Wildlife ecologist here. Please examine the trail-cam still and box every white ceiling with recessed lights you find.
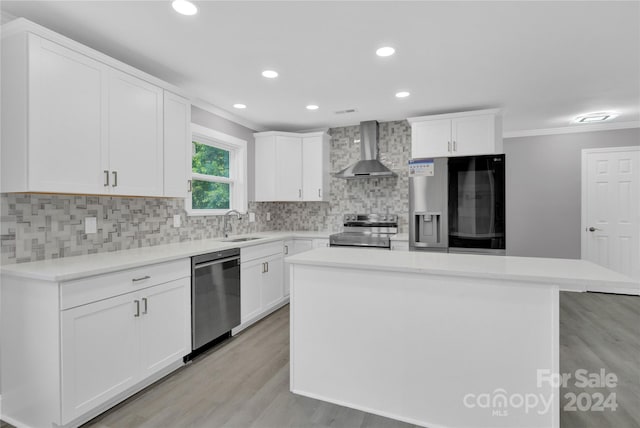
[0,0,640,132]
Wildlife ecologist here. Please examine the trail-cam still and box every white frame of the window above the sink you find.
[185,123,248,216]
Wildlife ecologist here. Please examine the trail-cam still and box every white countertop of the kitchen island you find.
[286,248,640,294]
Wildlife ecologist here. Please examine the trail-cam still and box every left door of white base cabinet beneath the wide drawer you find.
[61,293,141,424]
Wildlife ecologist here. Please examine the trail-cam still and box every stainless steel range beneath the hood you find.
[329,214,398,249]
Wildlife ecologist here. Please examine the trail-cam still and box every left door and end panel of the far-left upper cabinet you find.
[2,33,108,193]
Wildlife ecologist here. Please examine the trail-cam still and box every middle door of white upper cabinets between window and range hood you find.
[276,136,302,201]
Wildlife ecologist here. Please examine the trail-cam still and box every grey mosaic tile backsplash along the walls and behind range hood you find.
[0,121,411,264]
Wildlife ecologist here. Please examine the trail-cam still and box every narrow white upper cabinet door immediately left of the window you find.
[163,91,191,198]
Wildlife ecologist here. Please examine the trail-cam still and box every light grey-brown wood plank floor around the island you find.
[0,293,640,428]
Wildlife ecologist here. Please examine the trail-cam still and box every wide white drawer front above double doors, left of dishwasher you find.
[60,259,191,310]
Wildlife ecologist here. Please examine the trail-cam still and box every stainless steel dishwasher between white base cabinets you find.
[191,248,240,351]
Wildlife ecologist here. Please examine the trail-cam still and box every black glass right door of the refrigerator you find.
[448,155,505,252]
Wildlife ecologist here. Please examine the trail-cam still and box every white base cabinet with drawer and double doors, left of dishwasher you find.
[0,259,191,427]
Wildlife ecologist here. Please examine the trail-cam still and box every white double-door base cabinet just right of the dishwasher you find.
[240,241,287,332]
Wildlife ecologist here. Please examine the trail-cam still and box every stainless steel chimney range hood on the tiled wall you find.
[333,120,397,178]
